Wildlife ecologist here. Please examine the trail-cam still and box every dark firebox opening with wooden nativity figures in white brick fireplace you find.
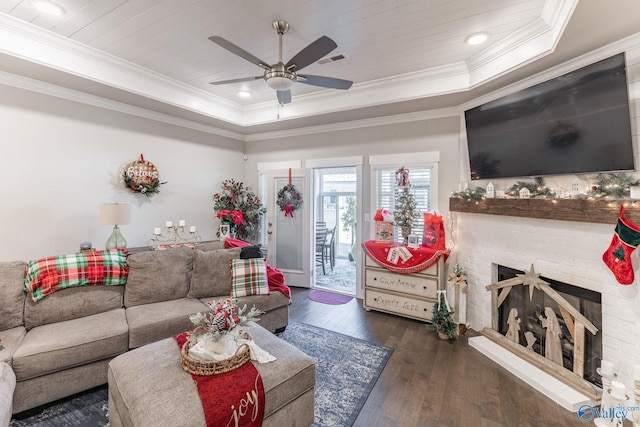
[494,266,602,387]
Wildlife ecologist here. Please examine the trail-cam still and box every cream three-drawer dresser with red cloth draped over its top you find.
[362,242,449,321]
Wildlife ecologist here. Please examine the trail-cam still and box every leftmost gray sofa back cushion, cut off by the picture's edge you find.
[0,261,27,331]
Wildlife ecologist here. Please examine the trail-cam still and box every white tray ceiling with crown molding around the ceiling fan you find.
[0,0,628,135]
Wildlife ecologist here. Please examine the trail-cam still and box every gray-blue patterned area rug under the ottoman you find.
[10,322,393,427]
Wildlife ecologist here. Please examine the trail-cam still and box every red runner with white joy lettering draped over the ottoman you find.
[173,332,264,427]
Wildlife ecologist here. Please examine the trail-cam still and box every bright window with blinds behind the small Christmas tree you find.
[373,167,432,241]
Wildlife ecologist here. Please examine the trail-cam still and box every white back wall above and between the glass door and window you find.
[245,116,460,244]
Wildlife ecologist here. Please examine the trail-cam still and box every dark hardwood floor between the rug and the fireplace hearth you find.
[289,288,600,427]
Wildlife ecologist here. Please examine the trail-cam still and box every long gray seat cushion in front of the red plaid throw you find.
[13,308,128,381]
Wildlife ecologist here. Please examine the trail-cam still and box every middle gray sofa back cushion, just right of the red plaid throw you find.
[124,248,193,307]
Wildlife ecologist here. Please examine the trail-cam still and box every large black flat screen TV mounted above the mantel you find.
[465,53,634,179]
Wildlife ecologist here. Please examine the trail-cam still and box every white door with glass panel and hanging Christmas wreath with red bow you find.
[266,169,312,288]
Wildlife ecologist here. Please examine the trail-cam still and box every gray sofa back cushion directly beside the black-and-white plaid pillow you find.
[187,248,241,298]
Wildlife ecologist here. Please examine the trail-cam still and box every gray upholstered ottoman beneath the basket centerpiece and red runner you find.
[108,324,316,427]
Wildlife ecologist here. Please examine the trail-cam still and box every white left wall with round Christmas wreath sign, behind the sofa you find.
[0,85,244,261]
